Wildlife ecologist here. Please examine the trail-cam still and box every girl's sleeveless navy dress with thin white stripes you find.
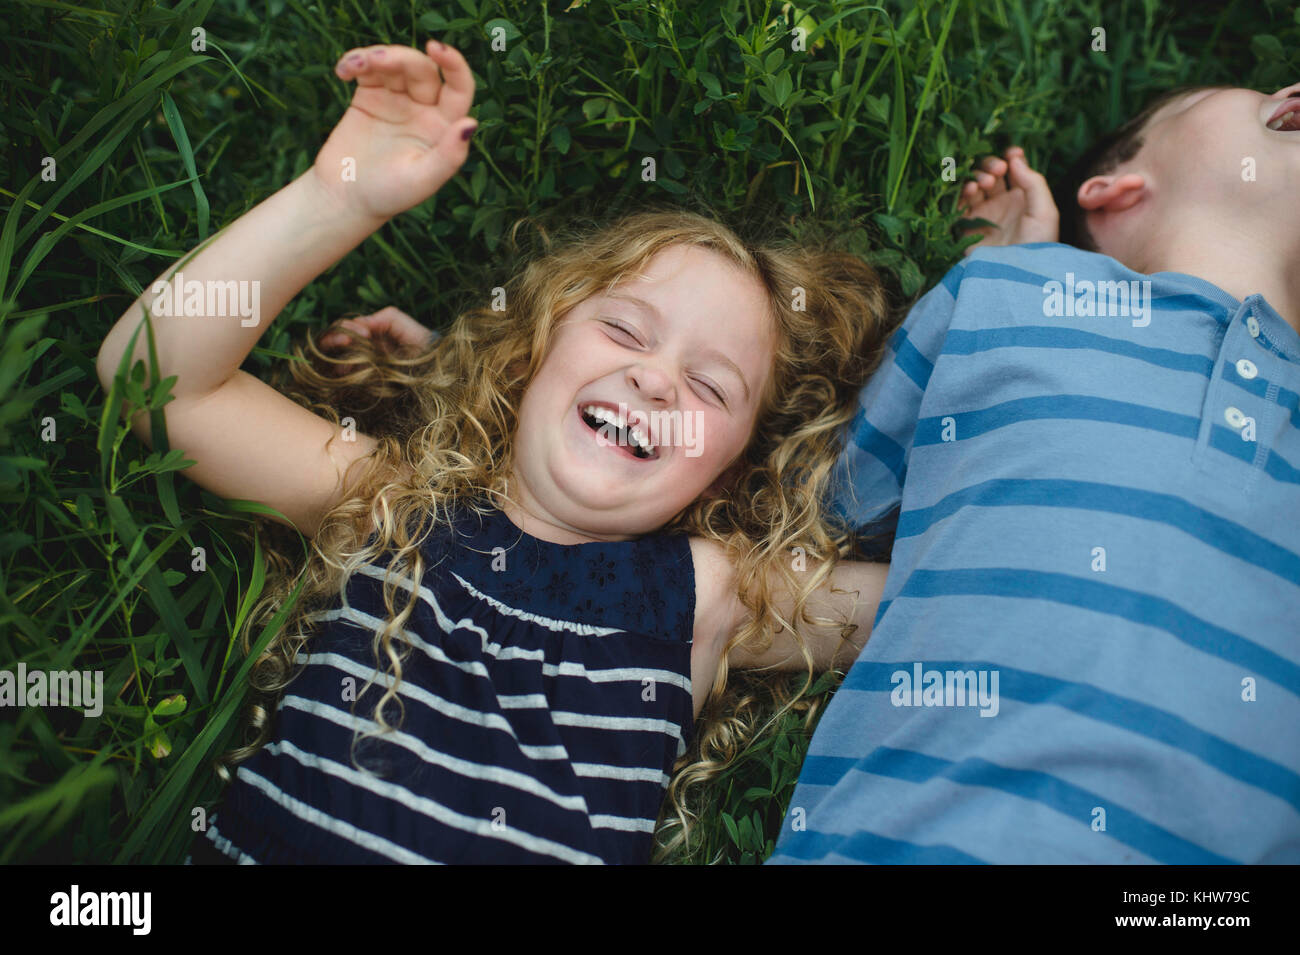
[192,509,696,864]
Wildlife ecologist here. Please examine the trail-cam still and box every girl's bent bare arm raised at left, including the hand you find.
[96,40,476,537]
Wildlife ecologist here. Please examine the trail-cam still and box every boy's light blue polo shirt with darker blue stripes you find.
[770,243,1300,864]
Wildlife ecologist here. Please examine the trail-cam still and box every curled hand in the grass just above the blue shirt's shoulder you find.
[958,146,1061,255]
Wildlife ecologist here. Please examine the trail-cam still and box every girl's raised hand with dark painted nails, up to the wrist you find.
[312,40,478,220]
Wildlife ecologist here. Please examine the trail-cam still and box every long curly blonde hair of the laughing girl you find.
[217,209,889,859]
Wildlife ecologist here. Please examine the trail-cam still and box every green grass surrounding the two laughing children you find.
[0,0,1300,863]
